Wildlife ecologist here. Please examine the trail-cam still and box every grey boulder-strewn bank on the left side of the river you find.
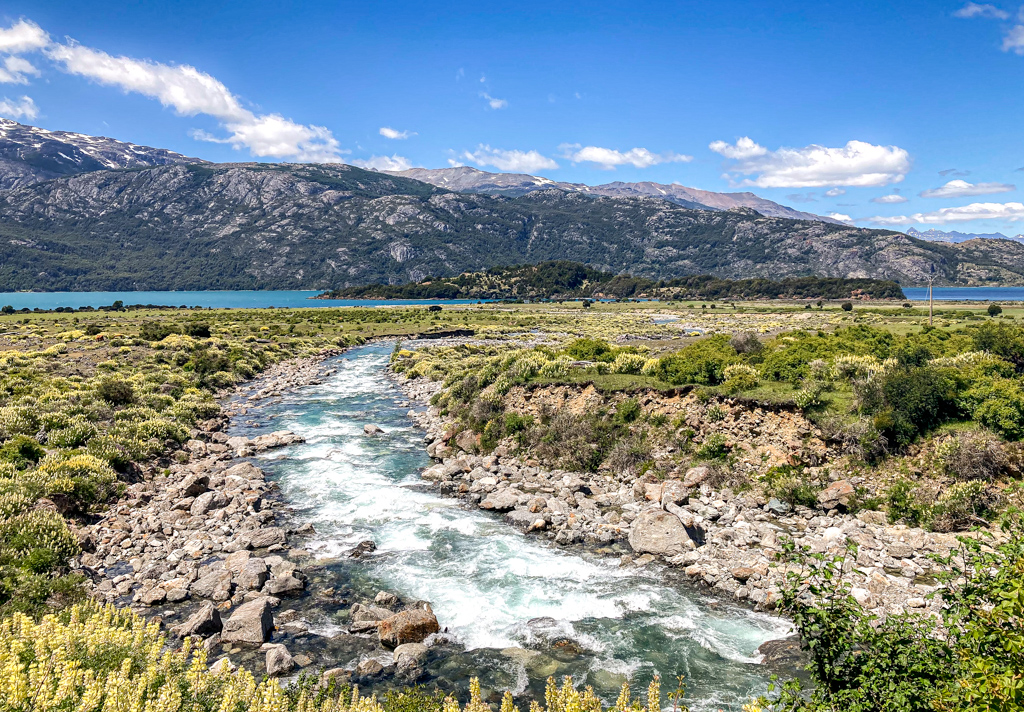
[78,349,443,683]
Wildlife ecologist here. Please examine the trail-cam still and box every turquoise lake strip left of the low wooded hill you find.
[0,290,487,309]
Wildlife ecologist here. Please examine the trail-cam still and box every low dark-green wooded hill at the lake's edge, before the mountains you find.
[316,260,905,300]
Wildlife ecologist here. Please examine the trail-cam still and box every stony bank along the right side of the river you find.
[396,376,974,615]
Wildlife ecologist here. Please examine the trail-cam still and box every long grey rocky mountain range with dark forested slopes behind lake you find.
[0,122,1024,291]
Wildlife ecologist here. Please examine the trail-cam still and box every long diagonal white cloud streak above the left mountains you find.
[46,42,343,162]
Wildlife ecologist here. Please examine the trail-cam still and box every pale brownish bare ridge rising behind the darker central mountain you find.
[382,166,842,224]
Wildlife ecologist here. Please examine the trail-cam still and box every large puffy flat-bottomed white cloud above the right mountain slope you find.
[710,138,910,187]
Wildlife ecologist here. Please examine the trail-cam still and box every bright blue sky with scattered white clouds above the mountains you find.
[0,0,1024,235]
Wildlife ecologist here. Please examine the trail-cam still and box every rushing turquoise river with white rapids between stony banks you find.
[234,344,790,710]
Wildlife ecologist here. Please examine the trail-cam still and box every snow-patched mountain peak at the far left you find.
[0,119,207,191]
